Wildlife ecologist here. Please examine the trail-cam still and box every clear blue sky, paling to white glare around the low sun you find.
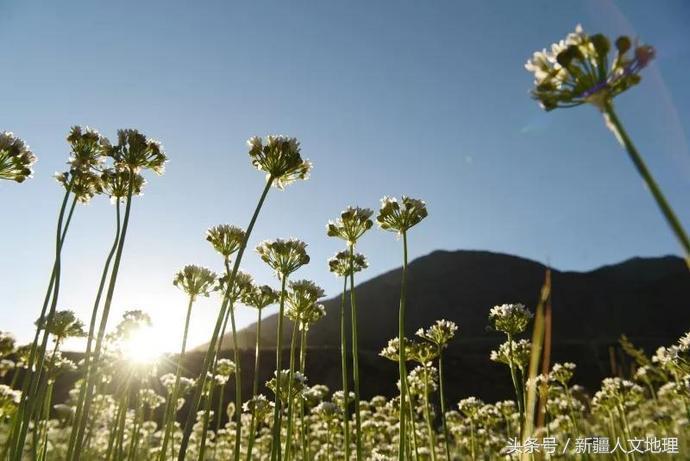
[0,0,690,347]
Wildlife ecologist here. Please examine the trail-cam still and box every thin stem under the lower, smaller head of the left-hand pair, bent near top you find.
[67,198,120,459]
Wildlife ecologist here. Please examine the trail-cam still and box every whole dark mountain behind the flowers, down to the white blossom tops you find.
[197,251,690,398]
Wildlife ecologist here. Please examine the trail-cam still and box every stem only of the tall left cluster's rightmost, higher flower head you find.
[69,169,134,461]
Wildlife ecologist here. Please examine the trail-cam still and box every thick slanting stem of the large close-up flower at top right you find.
[602,101,690,269]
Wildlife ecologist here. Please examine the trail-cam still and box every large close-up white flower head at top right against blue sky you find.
[525,25,654,110]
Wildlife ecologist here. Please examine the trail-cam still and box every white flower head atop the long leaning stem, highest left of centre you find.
[247,136,311,189]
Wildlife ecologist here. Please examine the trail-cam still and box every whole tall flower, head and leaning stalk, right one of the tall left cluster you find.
[67,129,167,461]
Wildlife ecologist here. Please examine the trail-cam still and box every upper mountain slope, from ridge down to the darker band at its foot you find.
[201,251,690,352]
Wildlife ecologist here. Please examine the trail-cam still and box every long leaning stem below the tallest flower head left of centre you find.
[178,177,274,461]
